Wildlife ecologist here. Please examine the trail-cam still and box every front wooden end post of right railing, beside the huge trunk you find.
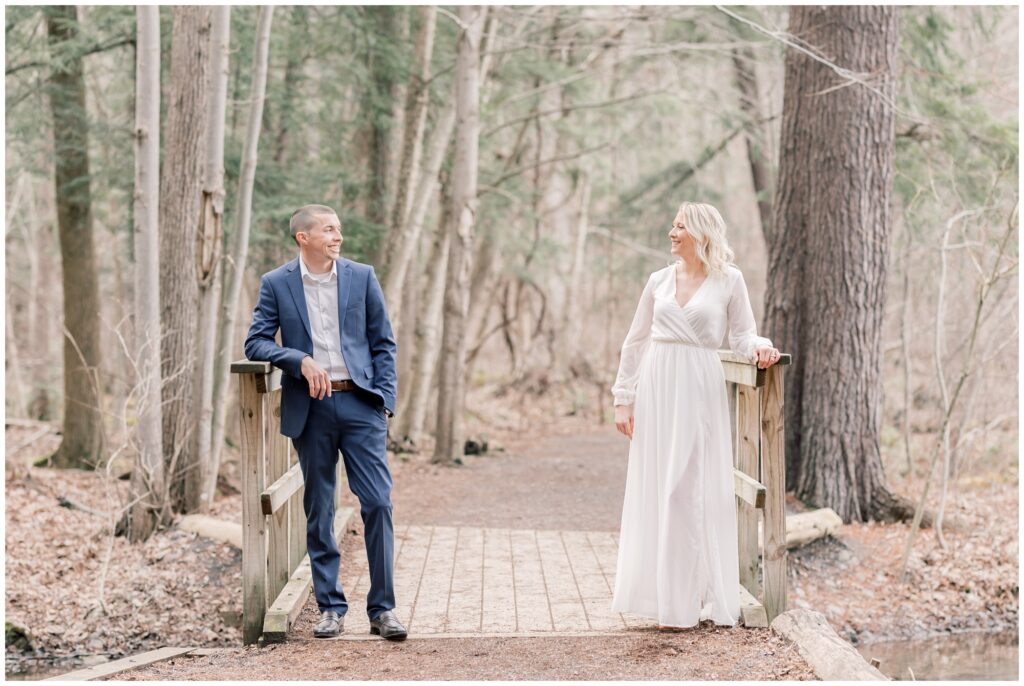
[761,365,788,621]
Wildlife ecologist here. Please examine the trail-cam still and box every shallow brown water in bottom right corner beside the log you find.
[857,631,1020,681]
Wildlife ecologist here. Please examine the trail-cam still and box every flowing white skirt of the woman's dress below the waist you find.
[612,340,739,627]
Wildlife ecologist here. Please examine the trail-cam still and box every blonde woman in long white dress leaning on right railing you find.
[611,203,779,628]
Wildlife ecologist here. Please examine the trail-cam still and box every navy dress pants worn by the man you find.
[292,391,394,619]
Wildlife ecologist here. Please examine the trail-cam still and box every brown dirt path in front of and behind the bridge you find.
[112,428,813,680]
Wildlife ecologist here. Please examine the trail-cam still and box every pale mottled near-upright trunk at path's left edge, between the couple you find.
[433,5,487,464]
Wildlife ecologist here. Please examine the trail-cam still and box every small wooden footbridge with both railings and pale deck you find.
[231,351,791,644]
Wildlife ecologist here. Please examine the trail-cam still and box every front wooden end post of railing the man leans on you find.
[239,373,266,645]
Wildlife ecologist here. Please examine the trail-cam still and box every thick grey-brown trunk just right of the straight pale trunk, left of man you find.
[160,6,211,511]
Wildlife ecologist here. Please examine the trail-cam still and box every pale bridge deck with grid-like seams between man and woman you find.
[342,525,653,639]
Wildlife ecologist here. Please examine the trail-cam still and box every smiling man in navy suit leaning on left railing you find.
[246,205,407,641]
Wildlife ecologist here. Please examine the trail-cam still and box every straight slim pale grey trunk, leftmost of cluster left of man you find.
[122,5,169,542]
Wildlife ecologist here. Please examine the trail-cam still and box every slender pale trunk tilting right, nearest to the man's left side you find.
[203,5,273,503]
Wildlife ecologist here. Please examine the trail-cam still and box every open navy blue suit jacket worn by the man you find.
[246,258,397,438]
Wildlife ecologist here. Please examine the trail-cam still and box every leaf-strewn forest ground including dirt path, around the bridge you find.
[5,389,1018,680]
